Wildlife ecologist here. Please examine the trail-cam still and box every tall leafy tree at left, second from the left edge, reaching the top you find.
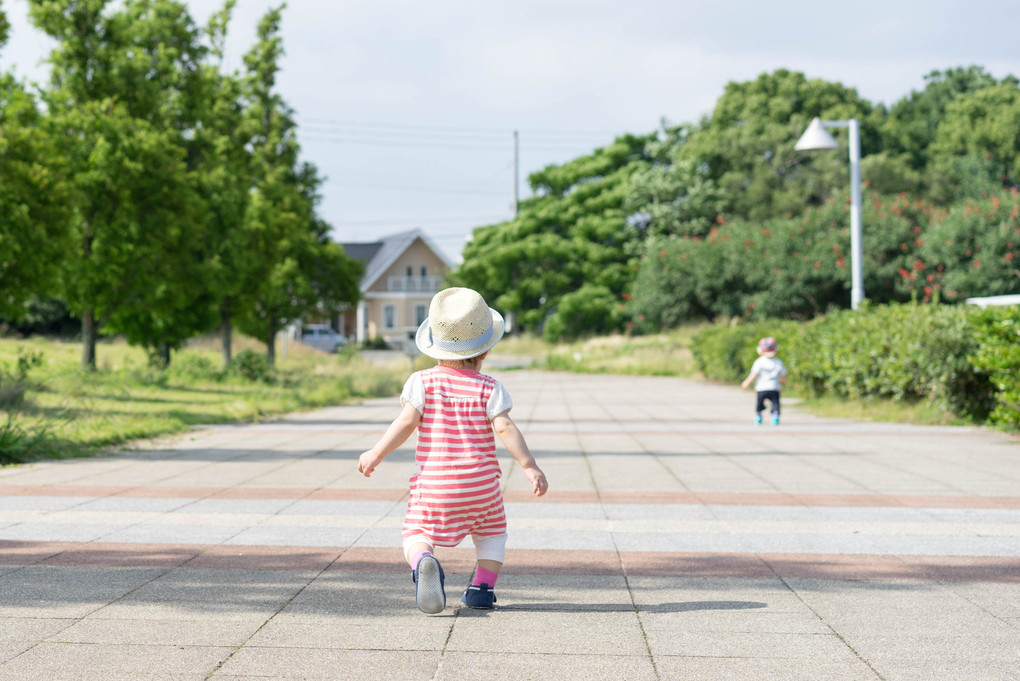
[30,0,211,368]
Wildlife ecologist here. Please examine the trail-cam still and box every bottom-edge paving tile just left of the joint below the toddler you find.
[213,646,442,681]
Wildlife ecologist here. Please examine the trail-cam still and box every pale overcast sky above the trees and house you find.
[0,0,1020,260]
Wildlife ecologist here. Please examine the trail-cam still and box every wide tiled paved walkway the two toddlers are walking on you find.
[0,370,1020,681]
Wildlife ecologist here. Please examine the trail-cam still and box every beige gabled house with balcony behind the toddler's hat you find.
[339,229,454,345]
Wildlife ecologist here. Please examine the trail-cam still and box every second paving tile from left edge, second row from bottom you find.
[52,618,258,647]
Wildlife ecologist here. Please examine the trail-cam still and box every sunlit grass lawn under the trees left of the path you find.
[0,337,422,463]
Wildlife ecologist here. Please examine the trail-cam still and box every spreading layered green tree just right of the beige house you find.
[451,135,652,337]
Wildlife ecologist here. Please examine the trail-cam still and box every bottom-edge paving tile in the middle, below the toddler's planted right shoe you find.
[436,650,656,681]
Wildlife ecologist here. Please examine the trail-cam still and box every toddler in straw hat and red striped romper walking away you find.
[358,289,549,615]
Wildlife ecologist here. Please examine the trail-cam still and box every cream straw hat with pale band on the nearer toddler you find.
[414,289,504,360]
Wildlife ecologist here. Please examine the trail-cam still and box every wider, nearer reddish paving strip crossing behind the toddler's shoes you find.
[0,541,1020,584]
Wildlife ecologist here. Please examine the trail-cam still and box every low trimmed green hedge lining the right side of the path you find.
[693,304,1020,428]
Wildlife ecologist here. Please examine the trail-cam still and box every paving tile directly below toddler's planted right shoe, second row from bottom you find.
[446,609,648,656]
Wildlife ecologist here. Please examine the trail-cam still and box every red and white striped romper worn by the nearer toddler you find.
[401,366,507,546]
